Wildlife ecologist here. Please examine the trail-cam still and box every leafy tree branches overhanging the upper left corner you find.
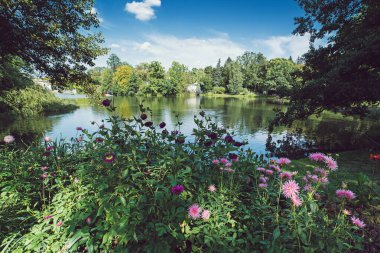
[0,0,106,86]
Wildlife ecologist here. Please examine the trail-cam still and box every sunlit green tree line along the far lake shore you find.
[88,52,302,96]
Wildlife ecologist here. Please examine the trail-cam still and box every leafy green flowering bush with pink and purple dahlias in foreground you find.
[0,104,363,252]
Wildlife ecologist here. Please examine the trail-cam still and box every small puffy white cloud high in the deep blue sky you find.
[125,0,161,21]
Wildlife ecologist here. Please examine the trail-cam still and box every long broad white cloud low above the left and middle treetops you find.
[96,34,246,69]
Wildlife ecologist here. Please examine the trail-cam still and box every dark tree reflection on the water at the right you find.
[267,115,380,157]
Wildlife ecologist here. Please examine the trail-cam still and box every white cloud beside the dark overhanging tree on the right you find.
[253,34,310,60]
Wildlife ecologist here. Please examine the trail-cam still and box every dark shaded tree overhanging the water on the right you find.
[275,0,380,124]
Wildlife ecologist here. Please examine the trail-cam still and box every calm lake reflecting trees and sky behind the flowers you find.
[0,94,380,154]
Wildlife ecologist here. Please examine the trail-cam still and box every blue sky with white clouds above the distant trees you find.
[91,0,309,69]
